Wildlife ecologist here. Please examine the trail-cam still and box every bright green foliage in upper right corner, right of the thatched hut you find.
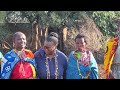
[87,11,120,36]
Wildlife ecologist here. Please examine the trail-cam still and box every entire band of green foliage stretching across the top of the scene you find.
[0,11,120,36]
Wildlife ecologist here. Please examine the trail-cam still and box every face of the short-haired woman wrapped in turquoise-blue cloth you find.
[75,38,86,51]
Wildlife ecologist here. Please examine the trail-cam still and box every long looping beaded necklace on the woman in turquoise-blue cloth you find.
[74,51,90,79]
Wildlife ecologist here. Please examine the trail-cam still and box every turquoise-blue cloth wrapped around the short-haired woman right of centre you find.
[66,51,98,79]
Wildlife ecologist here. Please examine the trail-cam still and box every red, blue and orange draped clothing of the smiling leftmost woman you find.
[1,49,36,79]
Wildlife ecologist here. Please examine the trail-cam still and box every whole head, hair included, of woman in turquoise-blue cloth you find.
[75,34,87,51]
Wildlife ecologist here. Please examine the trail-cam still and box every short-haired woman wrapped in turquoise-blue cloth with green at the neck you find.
[66,34,98,79]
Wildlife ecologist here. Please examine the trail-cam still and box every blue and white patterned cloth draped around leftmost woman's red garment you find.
[1,50,36,79]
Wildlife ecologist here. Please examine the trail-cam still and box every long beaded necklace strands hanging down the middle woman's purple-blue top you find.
[46,54,59,79]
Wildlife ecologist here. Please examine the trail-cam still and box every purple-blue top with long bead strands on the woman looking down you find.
[34,48,67,79]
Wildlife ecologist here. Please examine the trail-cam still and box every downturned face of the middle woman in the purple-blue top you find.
[43,41,56,55]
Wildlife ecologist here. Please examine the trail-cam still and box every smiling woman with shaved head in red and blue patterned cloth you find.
[1,32,36,79]
